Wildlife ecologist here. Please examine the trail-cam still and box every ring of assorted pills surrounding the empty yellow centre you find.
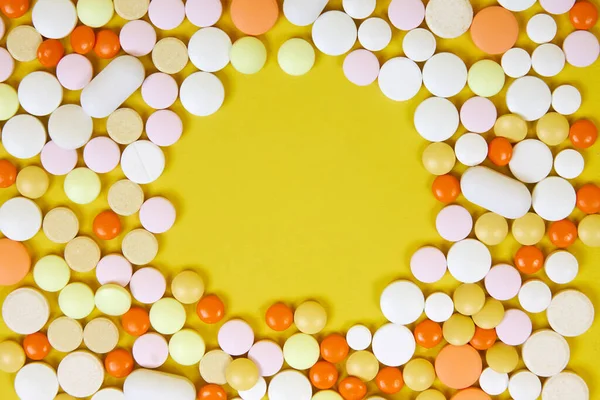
[0,0,600,400]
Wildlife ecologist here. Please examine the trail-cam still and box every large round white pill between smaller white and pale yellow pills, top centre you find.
[312,11,358,56]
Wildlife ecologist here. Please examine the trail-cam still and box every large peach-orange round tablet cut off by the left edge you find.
[0,238,31,286]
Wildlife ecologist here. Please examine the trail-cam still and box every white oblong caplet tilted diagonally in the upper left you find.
[81,56,144,118]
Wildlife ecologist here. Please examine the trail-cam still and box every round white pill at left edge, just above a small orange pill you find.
[2,114,46,159]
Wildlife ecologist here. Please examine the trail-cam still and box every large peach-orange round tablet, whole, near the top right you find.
[471,6,519,54]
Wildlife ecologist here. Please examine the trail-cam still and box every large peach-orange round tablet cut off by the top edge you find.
[230,0,279,36]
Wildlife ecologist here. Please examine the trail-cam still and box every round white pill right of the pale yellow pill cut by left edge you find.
[18,71,63,117]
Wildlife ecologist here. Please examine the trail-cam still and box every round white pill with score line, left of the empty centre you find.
[121,140,165,185]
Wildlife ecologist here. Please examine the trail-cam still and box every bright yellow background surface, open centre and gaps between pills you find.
[0,0,600,400]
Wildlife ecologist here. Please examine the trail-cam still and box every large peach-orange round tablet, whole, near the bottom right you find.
[435,344,482,389]
